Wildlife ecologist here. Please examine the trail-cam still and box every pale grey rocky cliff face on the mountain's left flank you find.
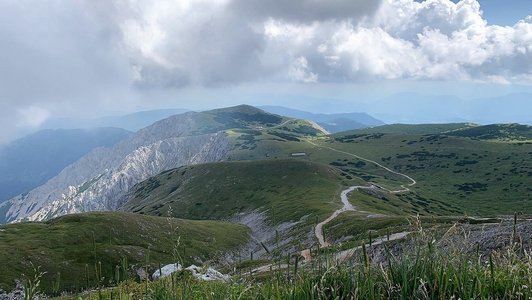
[6,113,229,222]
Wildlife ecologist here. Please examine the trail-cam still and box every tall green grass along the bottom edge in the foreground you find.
[72,226,532,299]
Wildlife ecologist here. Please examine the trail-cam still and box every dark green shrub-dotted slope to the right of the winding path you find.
[321,129,532,215]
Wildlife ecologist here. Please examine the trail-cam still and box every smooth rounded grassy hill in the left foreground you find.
[0,213,249,292]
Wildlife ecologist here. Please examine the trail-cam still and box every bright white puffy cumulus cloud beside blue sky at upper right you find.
[265,0,532,82]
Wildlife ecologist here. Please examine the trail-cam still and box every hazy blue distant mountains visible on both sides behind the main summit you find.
[0,106,383,220]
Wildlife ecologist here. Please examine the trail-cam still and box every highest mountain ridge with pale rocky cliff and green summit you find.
[6,105,321,222]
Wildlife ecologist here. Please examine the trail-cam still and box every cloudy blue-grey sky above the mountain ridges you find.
[0,0,532,143]
